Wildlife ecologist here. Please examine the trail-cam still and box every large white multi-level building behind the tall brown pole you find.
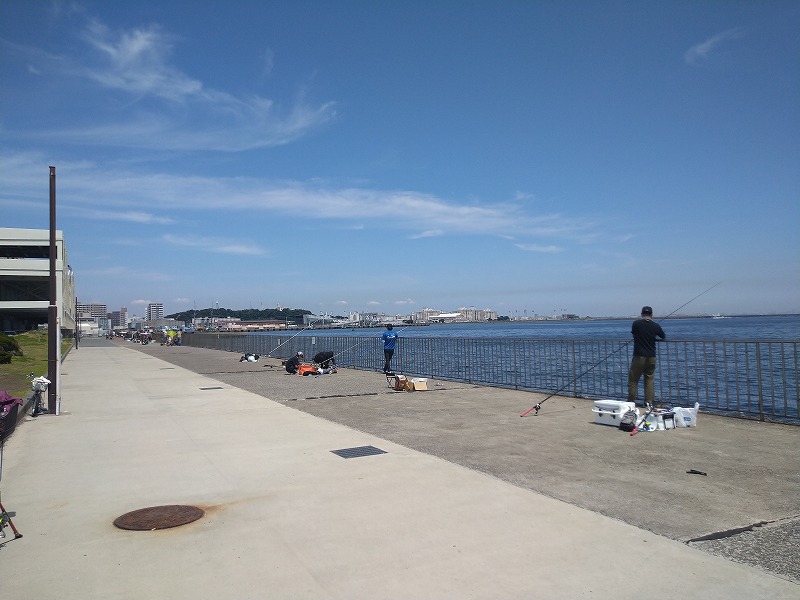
[0,227,76,334]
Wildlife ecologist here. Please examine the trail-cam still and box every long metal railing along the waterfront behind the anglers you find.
[183,333,800,423]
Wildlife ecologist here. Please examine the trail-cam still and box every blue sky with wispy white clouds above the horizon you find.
[0,0,800,316]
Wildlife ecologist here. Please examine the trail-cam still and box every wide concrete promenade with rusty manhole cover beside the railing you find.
[0,339,800,600]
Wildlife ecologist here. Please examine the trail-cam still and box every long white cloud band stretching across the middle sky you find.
[0,151,607,248]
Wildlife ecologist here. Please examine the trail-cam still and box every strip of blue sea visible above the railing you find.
[282,315,800,341]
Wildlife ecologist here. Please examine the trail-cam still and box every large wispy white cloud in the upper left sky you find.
[12,20,336,152]
